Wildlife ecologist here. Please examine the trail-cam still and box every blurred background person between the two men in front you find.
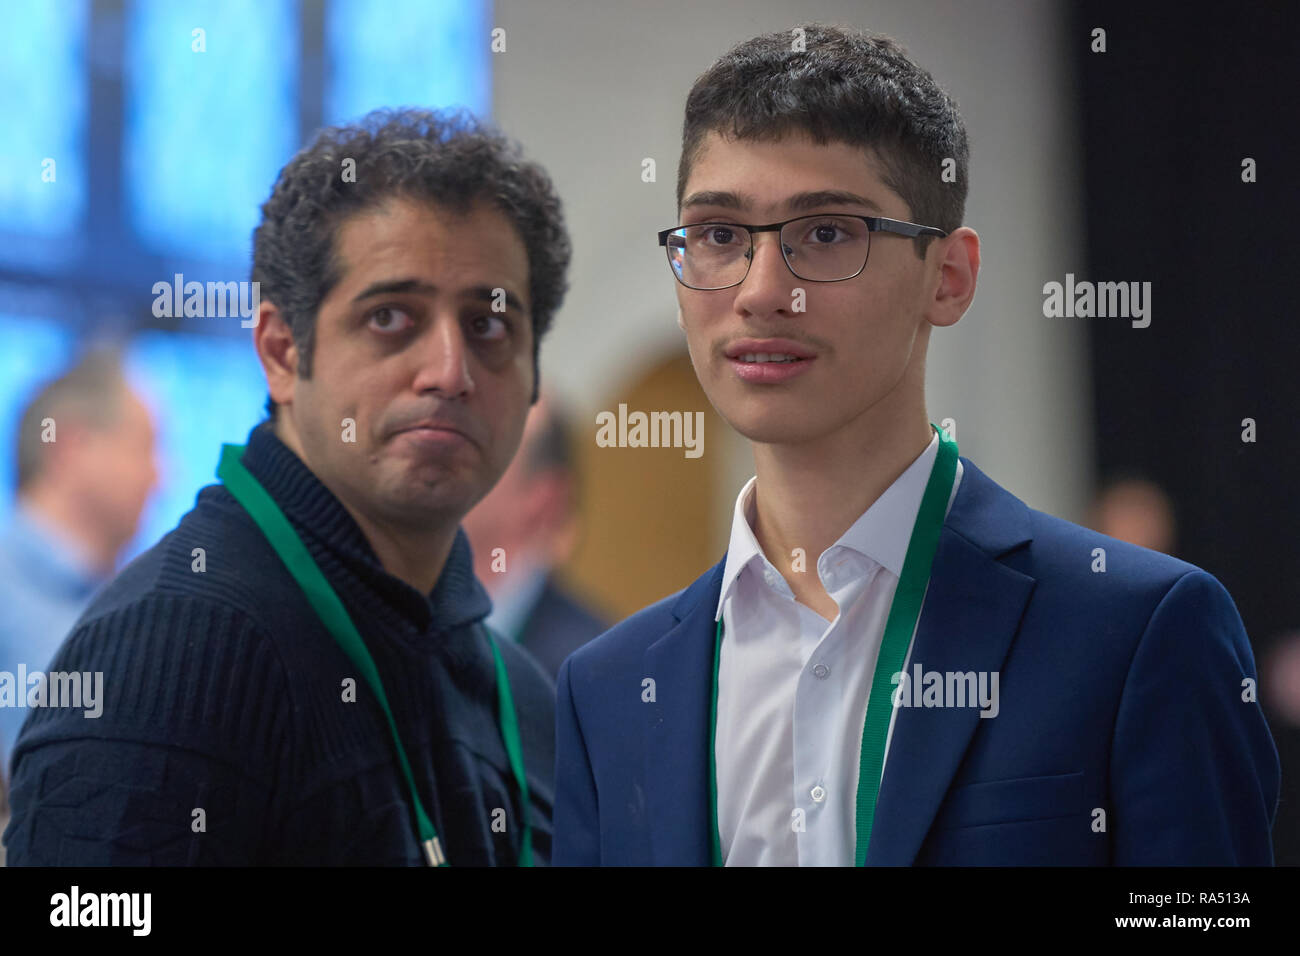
[464,394,610,678]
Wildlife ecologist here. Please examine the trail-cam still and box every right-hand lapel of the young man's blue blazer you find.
[867,458,1035,866]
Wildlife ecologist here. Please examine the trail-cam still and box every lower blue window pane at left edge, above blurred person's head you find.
[0,313,73,516]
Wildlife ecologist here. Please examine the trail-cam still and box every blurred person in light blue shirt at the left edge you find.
[0,349,157,775]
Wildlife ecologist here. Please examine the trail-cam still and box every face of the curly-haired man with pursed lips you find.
[294,202,533,533]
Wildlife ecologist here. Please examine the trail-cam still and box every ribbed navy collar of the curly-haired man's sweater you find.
[242,420,491,635]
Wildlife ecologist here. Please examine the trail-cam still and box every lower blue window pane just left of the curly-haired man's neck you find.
[122,332,267,561]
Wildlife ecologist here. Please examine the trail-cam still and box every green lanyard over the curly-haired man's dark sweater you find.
[217,445,533,866]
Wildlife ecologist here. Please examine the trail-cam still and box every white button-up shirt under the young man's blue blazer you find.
[715,434,962,866]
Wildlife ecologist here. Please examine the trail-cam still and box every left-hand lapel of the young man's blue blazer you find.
[644,557,727,866]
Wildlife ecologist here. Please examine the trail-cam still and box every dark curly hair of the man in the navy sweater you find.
[252,109,572,418]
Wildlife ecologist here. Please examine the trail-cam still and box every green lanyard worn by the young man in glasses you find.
[709,424,957,866]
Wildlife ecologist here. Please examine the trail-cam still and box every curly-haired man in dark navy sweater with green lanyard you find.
[5,111,569,865]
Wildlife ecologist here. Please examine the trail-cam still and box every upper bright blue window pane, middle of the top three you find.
[122,0,299,261]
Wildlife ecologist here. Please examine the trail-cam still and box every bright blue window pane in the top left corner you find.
[0,0,90,238]
